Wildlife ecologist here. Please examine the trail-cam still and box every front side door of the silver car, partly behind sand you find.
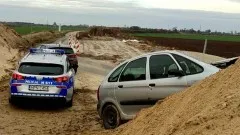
[149,54,187,104]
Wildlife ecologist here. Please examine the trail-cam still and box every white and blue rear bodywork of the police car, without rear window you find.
[10,48,75,101]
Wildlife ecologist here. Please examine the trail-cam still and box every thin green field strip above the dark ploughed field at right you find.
[132,33,240,42]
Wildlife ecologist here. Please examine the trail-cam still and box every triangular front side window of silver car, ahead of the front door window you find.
[172,54,204,75]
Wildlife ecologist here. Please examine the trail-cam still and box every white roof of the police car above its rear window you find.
[21,53,67,65]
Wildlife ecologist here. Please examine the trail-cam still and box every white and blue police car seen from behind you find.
[9,48,75,107]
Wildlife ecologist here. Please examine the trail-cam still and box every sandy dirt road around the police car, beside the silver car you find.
[0,33,119,135]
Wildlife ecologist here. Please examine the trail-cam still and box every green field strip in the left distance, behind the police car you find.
[12,26,87,35]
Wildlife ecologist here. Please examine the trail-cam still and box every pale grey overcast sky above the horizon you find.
[0,0,240,32]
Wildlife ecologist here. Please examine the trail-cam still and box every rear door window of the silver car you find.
[119,57,147,82]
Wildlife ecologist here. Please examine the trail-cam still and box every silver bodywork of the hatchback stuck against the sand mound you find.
[97,51,219,120]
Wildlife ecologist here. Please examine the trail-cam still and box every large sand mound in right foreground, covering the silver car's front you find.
[111,61,240,135]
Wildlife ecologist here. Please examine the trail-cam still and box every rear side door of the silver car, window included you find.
[115,57,148,115]
